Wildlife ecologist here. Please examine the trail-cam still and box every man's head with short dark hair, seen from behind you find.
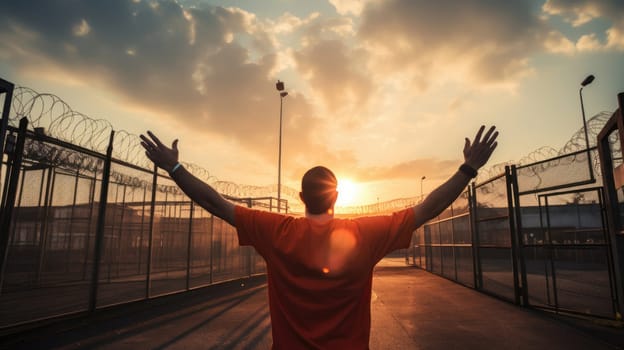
[299,166,338,215]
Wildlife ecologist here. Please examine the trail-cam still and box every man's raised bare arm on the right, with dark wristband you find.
[413,126,498,227]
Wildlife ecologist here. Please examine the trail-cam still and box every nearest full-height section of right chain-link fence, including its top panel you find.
[515,149,618,318]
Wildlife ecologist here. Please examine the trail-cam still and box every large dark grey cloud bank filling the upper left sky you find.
[0,0,322,164]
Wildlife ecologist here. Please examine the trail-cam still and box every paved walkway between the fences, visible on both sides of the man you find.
[0,261,624,350]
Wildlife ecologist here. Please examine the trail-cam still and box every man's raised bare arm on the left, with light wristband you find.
[141,131,235,225]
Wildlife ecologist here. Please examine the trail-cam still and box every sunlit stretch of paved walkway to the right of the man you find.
[370,265,624,350]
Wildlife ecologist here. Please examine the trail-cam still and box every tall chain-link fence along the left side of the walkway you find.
[0,119,276,328]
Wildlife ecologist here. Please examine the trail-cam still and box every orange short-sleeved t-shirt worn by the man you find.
[235,206,415,350]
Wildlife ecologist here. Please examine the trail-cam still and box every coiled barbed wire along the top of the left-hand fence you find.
[9,86,298,202]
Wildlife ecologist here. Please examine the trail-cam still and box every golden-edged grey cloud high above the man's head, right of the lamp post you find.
[268,13,375,132]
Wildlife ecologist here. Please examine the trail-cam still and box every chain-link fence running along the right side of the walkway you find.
[408,149,619,318]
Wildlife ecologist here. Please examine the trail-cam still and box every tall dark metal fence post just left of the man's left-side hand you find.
[89,130,115,312]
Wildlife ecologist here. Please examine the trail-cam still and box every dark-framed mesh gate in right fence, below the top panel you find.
[523,187,616,318]
